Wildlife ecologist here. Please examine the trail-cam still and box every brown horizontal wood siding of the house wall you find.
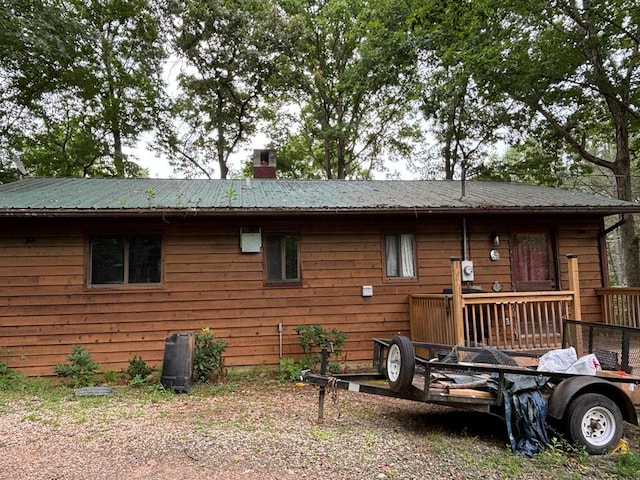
[0,216,602,375]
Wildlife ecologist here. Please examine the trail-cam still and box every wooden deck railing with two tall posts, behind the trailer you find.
[409,256,584,351]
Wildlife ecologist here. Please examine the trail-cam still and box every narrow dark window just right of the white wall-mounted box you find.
[265,235,300,283]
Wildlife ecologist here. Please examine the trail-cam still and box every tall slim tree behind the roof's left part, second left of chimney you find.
[62,0,166,177]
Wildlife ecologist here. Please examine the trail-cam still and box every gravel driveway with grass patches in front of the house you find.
[0,379,640,480]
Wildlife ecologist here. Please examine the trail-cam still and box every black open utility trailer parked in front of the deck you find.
[302,336,640,454]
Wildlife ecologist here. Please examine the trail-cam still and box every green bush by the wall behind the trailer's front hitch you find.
[295,325,347,373]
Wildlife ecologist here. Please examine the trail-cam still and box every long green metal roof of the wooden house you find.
[0,178,640,216]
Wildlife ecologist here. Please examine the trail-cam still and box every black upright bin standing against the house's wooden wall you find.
[160,333,195,393]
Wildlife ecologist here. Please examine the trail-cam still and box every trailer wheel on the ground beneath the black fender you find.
[566,393,623,455]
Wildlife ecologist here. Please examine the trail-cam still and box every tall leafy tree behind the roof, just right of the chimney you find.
[272,0,419,179]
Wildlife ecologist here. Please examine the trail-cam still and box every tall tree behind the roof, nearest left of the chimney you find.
[161,0,294,178]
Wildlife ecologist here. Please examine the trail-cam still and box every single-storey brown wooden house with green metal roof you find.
[0,174,640,375]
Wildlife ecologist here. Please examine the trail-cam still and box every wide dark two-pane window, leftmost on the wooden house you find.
[89,235,162,285]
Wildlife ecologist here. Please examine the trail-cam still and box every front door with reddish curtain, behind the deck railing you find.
[510,230,558,292]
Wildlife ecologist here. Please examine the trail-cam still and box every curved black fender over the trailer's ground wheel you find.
[547,376,638,425]
